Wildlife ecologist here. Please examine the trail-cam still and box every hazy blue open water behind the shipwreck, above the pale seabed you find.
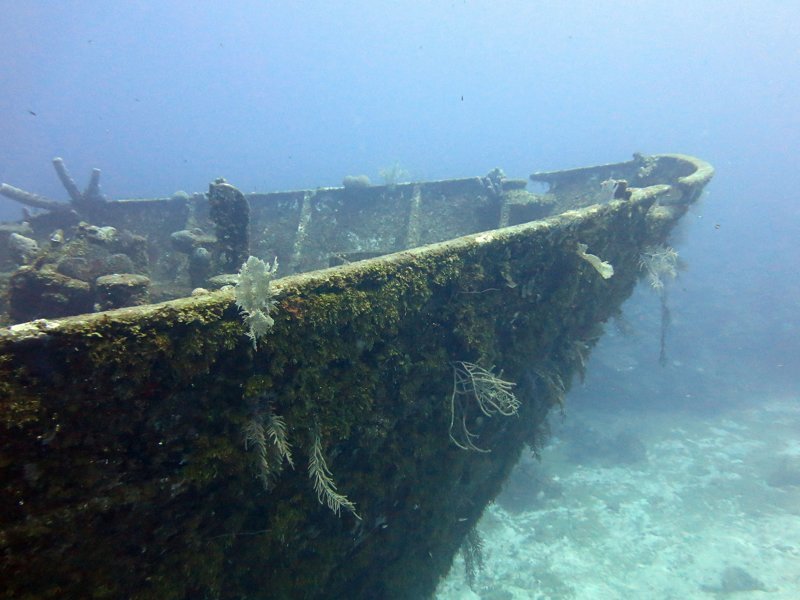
[0,0,800,596]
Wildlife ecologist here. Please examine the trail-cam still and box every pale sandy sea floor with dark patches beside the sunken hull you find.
[436,395,800,600]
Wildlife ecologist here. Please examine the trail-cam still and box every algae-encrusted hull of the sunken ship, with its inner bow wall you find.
[0,155,713,598]
